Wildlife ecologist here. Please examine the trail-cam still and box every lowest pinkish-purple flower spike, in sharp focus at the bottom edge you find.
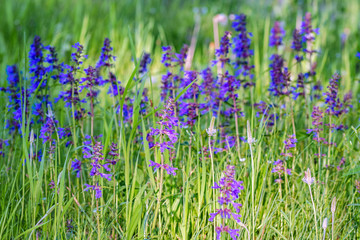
[209,165,244,239]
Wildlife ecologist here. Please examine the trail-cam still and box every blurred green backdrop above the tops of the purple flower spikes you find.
[0,0,360,88]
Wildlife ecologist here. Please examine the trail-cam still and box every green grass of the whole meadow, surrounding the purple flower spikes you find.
[0,0,360,239]
